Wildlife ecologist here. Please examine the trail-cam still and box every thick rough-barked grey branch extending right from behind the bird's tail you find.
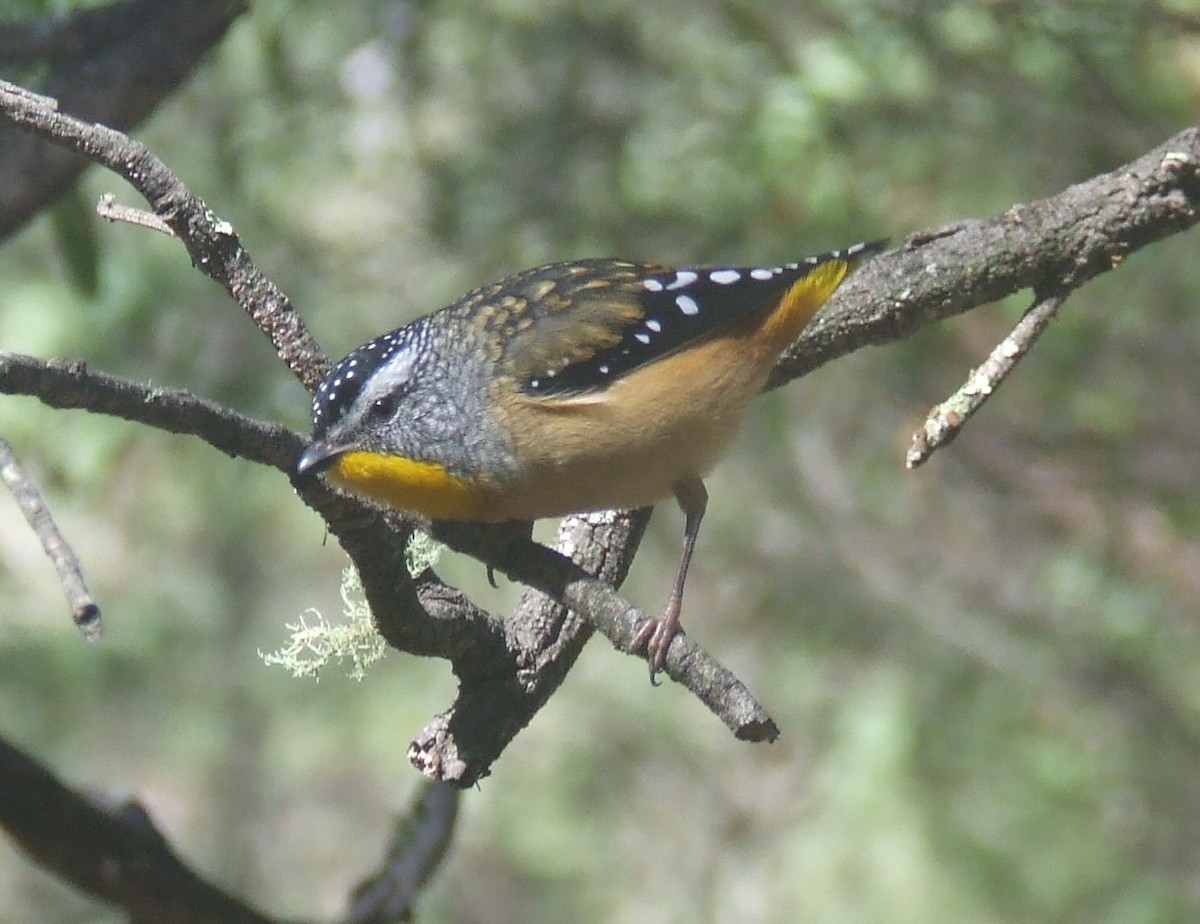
[769,135,1200,388]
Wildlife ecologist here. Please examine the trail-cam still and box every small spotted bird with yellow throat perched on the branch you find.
[295,241,886,679]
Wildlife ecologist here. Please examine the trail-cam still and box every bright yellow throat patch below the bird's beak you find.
[328,452,482,520]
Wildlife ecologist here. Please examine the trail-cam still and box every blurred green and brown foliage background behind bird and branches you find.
[0,0,1200,924]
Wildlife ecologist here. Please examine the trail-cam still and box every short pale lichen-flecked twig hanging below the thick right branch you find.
[905,293,1067,468]
